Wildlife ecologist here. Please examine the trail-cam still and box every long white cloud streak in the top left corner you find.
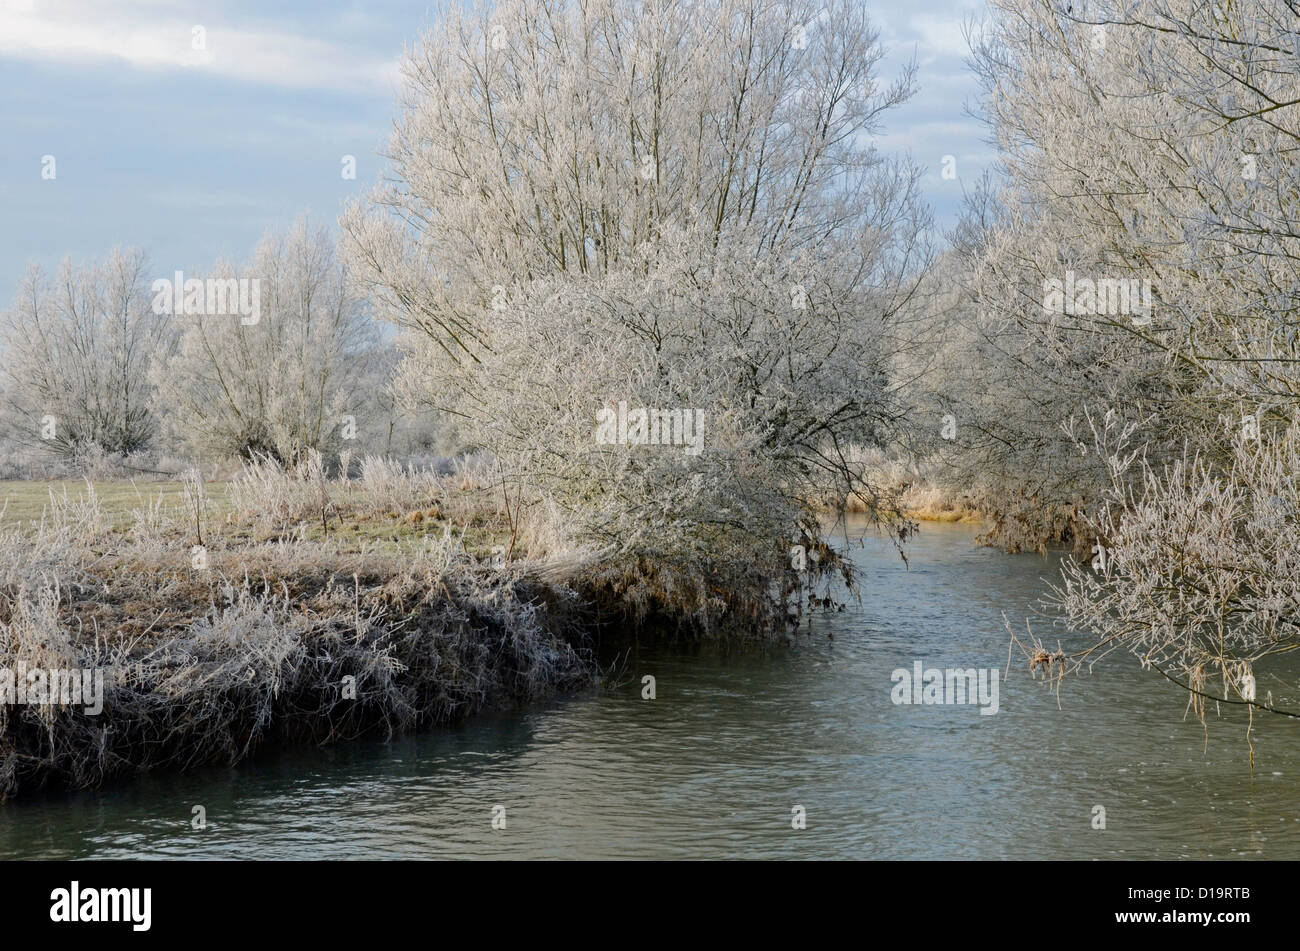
[0,0,398,91]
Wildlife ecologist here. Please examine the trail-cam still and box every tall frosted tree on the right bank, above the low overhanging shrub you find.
[948,0,1300,547]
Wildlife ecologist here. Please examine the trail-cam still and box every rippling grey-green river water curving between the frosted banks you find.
[0,524,1300,859]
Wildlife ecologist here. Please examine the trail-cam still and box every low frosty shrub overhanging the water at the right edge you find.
[1017,417,1300,748]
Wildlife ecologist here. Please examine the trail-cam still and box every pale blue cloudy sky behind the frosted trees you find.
[0,0,991,309]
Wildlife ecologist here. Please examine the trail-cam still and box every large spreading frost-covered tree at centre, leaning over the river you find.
[345,0,927,631]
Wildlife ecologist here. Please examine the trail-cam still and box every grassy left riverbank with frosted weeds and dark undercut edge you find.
[0,461,598,798]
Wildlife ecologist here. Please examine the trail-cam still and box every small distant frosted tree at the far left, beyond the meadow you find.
[0,249,161,456]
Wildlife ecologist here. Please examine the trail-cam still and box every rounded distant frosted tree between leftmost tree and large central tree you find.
[152,220,378,464]
